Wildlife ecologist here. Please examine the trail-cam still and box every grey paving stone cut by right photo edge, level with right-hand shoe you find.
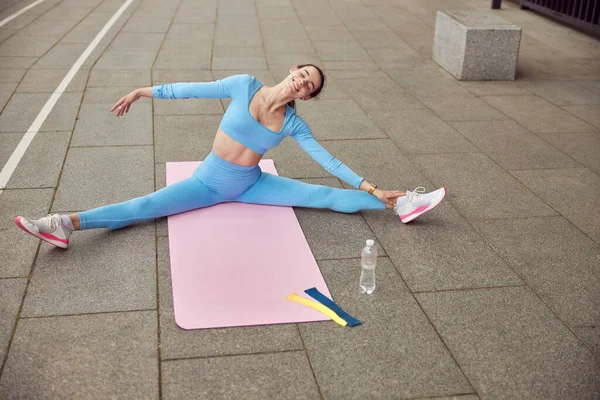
[511,168,600,244]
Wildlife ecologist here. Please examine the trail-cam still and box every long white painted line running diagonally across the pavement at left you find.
[0,0,133,194]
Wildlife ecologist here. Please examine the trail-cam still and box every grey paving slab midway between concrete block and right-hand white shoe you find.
[369,110,479,154]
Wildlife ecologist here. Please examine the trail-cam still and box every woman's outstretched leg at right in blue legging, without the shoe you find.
[236,172,385,213]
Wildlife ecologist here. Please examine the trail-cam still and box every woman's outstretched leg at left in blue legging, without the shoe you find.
[77,176,223,229]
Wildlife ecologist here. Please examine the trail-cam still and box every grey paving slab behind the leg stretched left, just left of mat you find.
[53,146,154,211]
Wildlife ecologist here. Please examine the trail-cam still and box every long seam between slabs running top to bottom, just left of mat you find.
[145,0,182,400]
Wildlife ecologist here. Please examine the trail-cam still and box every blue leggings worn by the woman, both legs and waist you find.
[78,152,385,229]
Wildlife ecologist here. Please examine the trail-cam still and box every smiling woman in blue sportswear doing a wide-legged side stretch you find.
[15,64,445,249]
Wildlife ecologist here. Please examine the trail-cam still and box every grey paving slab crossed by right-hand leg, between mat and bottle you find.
[294,178,385,260]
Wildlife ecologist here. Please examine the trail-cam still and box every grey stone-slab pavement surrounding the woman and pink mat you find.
[0,0,600,400]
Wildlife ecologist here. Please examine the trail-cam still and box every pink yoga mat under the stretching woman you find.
[167,160,331,329]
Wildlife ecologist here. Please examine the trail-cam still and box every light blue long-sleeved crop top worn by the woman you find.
[152,75,363,188]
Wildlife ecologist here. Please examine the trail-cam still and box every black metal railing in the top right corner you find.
[502,0,600,37]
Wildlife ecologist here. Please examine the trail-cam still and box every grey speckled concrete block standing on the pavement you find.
[433,11,521,80]
